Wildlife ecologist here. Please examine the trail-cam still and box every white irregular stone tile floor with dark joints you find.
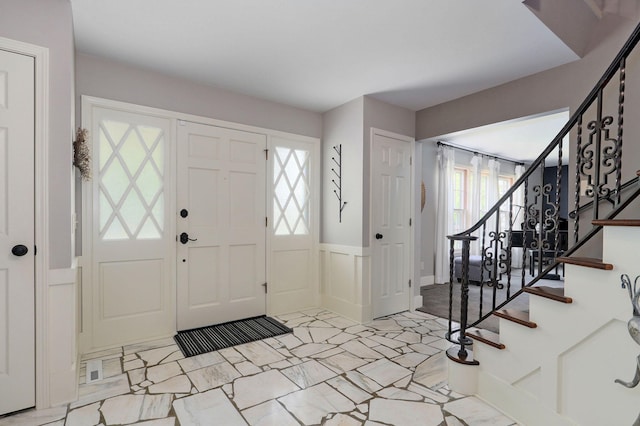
[0,309,515,426]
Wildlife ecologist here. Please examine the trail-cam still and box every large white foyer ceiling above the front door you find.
[71,0,577,112]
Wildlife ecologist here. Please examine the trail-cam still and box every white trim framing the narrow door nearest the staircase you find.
[368,127,419,315]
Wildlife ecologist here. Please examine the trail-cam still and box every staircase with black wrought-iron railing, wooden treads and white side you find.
[447,16,640,426]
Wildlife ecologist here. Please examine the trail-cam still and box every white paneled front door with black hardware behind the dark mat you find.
[177,122,266,330]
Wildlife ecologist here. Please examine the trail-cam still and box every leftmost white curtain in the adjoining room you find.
[435,145,455,284]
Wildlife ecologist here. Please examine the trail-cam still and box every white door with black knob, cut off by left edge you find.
[0,50,35,415]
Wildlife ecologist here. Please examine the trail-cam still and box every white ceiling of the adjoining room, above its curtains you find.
[434,111,569,165]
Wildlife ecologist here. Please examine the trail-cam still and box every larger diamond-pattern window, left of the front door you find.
[98,120,165,240]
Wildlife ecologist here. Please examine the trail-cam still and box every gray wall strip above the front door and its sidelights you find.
[76,53,322,137]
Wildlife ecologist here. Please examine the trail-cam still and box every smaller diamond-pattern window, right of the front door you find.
[273,147,310,236]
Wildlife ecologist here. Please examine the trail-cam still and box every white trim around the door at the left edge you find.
[0,37,50,408]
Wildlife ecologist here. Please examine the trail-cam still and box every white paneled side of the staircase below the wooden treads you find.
[473,227,640,426]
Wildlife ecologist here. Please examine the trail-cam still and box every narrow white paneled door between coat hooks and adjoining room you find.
[371,131,411,318]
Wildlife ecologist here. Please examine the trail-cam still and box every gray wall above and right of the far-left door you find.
[0,0,74,269]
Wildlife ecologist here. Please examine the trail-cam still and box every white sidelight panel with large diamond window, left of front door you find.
[83,104,175,348]
